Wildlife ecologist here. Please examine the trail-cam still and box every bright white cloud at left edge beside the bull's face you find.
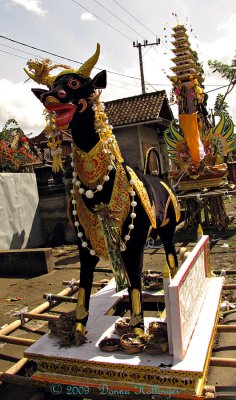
[0,79,45,135]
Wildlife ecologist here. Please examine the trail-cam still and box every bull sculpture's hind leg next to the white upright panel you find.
[158,221,178,278]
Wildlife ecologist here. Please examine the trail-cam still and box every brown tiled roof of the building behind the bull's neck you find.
[105,90,173,127]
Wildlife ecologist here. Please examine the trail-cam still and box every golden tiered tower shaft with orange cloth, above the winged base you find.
[167,24,206,164]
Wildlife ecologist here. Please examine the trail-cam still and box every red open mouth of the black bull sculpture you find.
[45,100,77,127]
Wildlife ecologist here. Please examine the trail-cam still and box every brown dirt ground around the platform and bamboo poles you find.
[0,198,236,400]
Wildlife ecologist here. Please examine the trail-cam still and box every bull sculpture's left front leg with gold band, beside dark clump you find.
[75,247,99,345]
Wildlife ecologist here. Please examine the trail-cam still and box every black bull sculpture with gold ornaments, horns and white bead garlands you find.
[26,45,178,343]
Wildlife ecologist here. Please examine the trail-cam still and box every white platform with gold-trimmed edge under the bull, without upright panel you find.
[25,278,223,400]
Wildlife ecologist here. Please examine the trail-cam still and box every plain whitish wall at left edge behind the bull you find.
[0,172,44,250]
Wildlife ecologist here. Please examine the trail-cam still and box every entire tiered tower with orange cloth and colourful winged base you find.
[165,24,236,189]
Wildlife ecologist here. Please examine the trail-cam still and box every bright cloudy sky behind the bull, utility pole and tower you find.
[0,0,236,135]
